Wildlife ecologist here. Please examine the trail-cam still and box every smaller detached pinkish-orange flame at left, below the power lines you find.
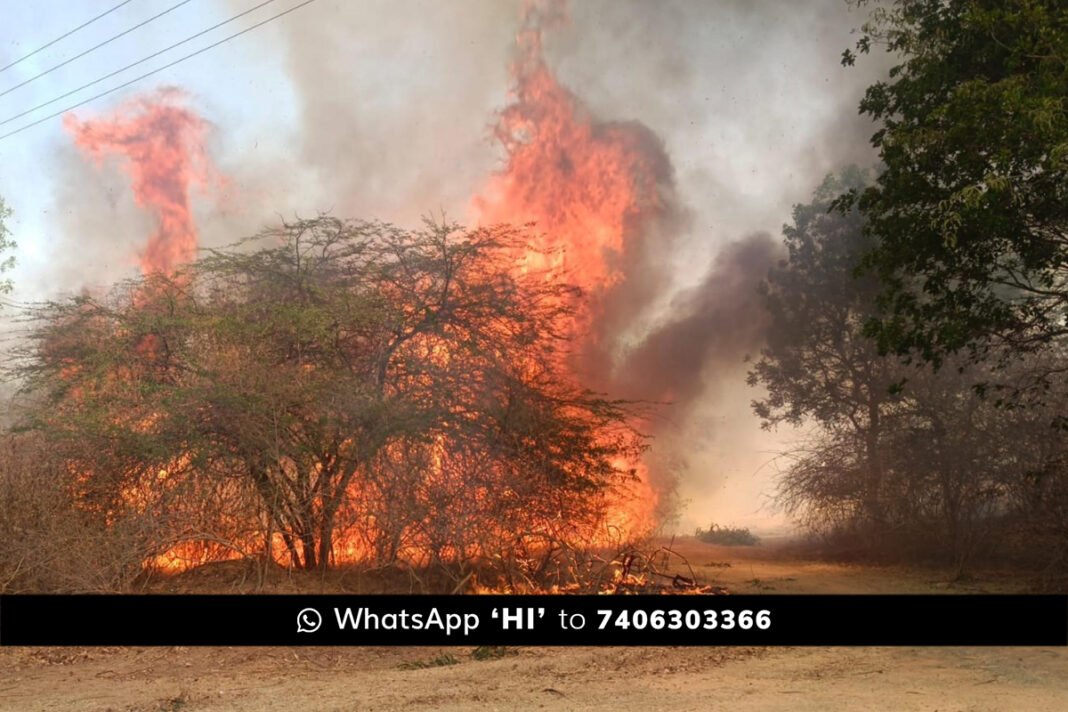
[63,89,213,274]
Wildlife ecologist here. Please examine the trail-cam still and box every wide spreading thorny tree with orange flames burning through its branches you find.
[14,217,644,580]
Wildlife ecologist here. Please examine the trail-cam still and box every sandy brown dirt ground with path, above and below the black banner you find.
[0,540,1068,712]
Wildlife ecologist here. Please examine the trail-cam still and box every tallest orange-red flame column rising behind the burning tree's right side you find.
[474,3,671,533]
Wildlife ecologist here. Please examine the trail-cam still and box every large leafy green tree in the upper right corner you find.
[844,0,1068,373]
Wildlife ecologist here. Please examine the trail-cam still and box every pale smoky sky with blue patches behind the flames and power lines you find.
[0,0,885,531]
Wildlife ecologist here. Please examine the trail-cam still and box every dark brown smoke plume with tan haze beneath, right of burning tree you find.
[604,225,782,517]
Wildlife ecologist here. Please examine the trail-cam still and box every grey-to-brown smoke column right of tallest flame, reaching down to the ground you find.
[519,0,892,526]
